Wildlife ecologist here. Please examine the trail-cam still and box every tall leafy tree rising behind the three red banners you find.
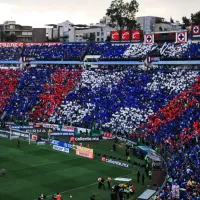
[106,0,139,30]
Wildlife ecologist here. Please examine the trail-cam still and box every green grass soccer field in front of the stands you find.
[0,138,149,200]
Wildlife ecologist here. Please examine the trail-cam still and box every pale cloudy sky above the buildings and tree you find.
[0,0,200,28]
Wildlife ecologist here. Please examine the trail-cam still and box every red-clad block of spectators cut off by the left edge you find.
[0,68,22,116]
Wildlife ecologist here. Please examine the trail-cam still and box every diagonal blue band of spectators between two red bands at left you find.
[5,66,54,118]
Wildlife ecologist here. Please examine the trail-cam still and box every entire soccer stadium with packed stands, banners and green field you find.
[0,1,200,200]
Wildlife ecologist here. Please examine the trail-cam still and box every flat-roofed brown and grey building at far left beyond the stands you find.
[0,21,46,42]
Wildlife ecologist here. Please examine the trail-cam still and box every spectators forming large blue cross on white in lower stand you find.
[51,67,198,133]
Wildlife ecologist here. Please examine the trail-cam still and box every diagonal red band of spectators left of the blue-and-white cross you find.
[29,66,82,122]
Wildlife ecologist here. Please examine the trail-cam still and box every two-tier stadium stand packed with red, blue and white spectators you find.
[0,43,200,199]
